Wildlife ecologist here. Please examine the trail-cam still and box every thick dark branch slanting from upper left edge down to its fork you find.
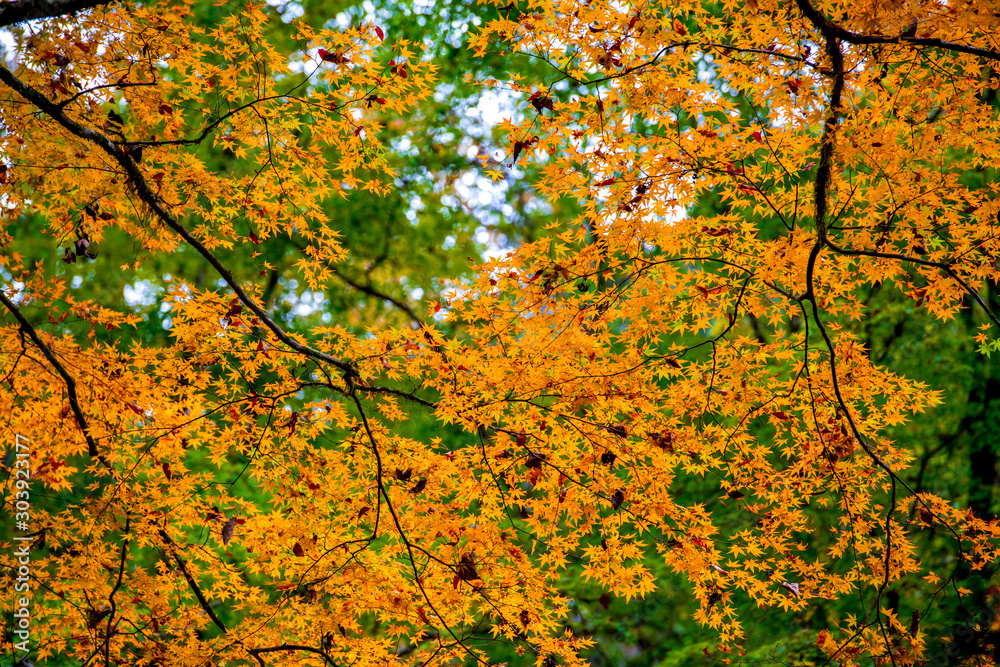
[0,60,355,374]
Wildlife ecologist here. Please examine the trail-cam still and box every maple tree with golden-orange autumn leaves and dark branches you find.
[0,0,1000,665]
